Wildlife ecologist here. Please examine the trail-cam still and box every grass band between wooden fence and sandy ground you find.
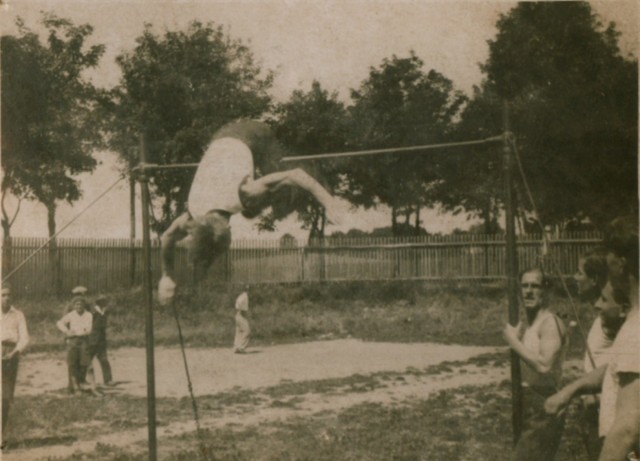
[18,282,591,354]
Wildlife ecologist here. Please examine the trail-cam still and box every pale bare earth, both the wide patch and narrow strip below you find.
[2,339,508,461]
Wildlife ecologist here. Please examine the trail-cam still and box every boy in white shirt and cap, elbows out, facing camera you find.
[56,295,93,393]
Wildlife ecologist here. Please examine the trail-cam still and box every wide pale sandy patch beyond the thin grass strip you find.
[16,339,497,397]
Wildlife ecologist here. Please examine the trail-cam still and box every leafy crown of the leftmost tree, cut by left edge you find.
[2,14,104,235]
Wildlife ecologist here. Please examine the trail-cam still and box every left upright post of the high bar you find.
[138,132,157,461]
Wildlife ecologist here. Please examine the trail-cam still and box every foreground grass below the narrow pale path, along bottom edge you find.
[46,382,583,461]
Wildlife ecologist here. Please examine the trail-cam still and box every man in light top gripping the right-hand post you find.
[503,268,568,461]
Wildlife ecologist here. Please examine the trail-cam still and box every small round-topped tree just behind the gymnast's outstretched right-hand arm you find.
[267,81,349,239]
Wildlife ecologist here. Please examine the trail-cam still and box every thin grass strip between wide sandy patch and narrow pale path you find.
[7,354,504,448]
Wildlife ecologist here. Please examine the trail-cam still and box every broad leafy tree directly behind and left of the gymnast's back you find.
[112,21,272,232]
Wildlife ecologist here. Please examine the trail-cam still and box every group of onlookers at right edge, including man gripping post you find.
[504,216,640,461]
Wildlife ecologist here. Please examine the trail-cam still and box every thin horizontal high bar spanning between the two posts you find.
[132,135,504,172]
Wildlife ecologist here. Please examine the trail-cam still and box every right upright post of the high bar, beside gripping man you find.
[502,101,522,444]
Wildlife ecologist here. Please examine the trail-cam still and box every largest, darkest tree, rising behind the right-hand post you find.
[483,2,638,225]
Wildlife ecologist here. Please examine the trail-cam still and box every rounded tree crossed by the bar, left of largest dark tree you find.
[347,52,466,234]
